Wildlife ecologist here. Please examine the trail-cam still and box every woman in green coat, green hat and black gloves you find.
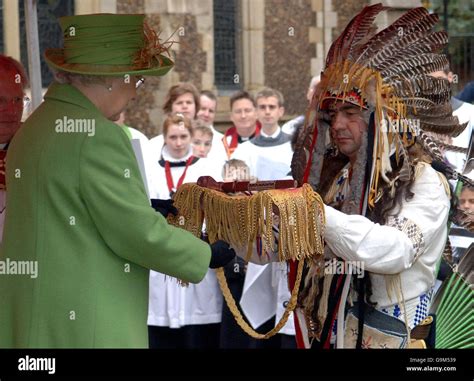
[0,14,235,348]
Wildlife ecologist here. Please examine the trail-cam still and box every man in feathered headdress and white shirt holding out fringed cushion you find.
[292,4,469,348]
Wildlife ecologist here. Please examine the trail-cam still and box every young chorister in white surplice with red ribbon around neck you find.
[148,114,222,349]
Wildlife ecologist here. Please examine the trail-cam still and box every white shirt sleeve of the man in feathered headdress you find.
[325,166,450,274]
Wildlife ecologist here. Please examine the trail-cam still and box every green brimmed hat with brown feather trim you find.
[45,14,173,76]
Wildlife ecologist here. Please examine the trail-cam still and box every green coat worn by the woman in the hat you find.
[0,84,210,348]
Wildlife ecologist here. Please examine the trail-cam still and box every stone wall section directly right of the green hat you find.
[117,0,214,137]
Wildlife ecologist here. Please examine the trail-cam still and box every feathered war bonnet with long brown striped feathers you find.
[292,4,466,214]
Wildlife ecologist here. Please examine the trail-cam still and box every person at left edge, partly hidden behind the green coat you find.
[0,54,28,243]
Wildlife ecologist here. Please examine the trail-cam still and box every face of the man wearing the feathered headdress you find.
[329,102,367,161]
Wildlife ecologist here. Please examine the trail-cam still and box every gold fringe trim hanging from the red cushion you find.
[168,183,325,261]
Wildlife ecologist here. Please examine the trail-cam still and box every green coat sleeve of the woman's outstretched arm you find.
[80,121,211,283]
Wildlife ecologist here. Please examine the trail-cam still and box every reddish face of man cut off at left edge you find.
[0,68,24,143]
